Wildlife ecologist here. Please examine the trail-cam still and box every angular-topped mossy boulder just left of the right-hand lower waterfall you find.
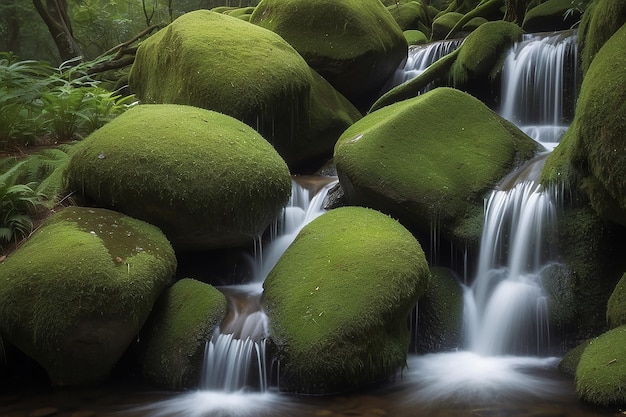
[334,87,538,252]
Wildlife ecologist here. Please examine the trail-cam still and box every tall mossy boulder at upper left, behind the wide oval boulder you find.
[129,10,361,168]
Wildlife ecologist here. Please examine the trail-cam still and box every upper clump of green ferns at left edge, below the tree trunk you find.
[0,52,132,150]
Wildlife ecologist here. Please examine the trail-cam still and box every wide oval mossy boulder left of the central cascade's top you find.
[67,104,291,250]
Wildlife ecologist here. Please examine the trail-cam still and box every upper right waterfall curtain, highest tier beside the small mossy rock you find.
[500,32,577,150]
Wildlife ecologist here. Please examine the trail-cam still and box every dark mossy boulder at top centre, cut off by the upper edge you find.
[250,0,407,108]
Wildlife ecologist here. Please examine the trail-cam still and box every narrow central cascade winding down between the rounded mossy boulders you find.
[201,178,337,393]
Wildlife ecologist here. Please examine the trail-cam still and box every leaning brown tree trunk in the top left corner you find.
[33,0,81,61]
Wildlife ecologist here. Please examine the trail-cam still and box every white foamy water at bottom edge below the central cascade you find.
[128,391,289,417]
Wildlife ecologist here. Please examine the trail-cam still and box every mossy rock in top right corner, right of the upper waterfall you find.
[578,0,626,74]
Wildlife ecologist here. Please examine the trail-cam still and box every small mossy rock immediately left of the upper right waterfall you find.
[451,21,522,85]
